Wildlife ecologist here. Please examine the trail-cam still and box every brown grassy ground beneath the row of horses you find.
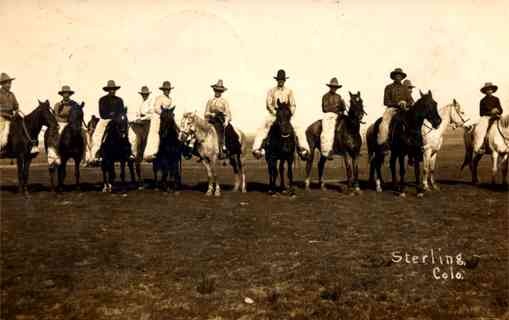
[0,129,509,320]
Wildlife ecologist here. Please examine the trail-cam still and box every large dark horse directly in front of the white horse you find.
[366,91,442,198]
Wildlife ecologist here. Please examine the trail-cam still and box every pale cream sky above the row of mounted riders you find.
[0,0,509,132]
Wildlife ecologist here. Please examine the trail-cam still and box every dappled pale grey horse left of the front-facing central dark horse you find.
[179,112,246,197]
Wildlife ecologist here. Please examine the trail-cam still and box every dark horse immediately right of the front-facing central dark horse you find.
[305,92,366,192]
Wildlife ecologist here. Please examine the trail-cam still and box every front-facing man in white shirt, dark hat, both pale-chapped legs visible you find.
[253,69,309,159]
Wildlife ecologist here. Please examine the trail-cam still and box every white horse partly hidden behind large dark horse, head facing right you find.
[421,99,466,191]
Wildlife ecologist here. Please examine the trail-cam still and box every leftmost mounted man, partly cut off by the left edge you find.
[0,73,39,155]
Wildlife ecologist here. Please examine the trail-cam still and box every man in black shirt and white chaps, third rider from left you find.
[88,80,129,164]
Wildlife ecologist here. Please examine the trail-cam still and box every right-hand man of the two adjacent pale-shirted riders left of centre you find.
[144,81,175,161]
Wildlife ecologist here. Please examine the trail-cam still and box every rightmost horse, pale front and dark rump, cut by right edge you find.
[461,115,509,186]
